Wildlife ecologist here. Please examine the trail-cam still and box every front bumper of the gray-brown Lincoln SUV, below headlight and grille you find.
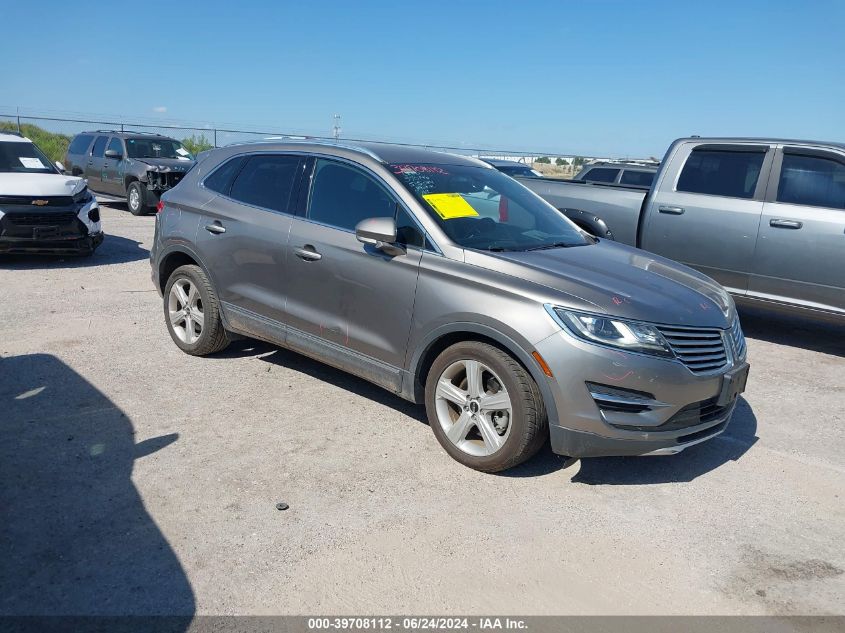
[536,331,744,457]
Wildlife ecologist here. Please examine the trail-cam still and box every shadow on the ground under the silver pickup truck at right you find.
[740,308,845,357]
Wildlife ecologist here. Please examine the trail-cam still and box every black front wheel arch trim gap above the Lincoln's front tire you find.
[403,322,558,421]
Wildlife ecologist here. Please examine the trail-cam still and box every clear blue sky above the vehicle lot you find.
[0,0,845,156]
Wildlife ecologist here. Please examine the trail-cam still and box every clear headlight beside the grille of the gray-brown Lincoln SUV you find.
[553,308,673,356]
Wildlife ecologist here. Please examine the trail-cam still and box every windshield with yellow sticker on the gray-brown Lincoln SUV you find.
[391,164,590,251]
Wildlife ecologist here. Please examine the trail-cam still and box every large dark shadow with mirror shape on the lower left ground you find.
[0,354,195,620]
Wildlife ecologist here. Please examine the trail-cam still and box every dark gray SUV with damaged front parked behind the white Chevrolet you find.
[65,130,194,215]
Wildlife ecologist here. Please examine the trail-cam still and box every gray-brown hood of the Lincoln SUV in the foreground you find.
[466,240,735,328]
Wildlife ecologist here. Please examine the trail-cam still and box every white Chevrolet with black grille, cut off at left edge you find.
[0,133,103,255]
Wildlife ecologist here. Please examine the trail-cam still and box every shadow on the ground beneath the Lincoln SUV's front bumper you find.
[500,397,757,486]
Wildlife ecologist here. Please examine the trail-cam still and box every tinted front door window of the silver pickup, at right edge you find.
[778,154,845,209]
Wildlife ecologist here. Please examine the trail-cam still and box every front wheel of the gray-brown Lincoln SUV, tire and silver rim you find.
[425,341,548,473]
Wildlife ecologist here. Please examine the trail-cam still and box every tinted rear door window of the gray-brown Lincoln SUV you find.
[229,154,299,212]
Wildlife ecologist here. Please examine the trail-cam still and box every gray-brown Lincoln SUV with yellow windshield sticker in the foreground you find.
[151,142,748,472]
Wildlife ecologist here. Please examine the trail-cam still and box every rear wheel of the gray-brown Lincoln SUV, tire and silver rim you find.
[164,264,229,356]
